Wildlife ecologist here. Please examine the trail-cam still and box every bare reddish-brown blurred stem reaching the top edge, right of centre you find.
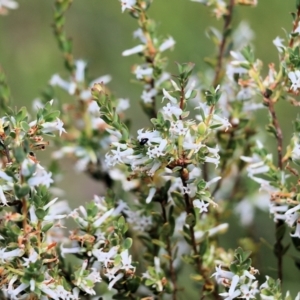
[213,0,235,87]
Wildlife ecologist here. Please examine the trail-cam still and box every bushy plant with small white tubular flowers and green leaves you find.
[0,0,300,300]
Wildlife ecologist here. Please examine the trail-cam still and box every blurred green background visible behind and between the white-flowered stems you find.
[0,0,300,299]
